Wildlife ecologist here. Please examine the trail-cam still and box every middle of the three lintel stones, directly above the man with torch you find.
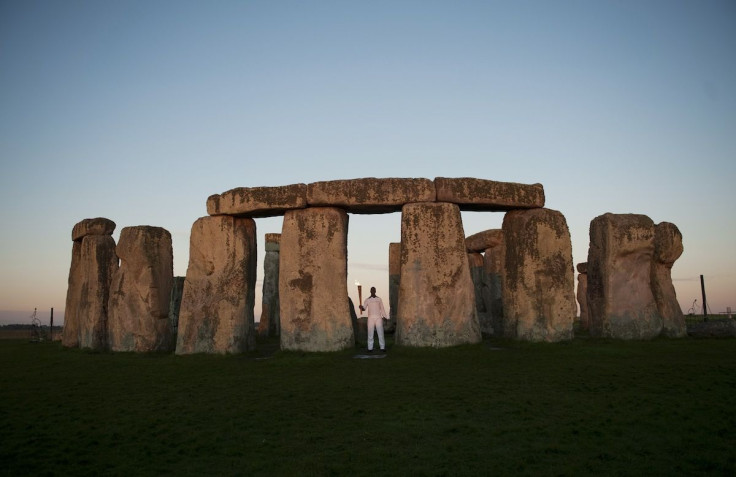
[307,177,435,214]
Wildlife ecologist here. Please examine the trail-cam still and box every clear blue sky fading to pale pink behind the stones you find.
[0,0,736,323]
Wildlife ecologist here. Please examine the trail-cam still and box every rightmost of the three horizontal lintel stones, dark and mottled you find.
[434,177,544,211]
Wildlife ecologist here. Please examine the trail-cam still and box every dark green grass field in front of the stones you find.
[0,338,736,476]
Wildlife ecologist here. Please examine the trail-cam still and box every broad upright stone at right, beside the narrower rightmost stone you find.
[588,213,662,339]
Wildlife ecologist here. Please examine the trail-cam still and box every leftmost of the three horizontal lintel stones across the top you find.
[207,184,307,217]
